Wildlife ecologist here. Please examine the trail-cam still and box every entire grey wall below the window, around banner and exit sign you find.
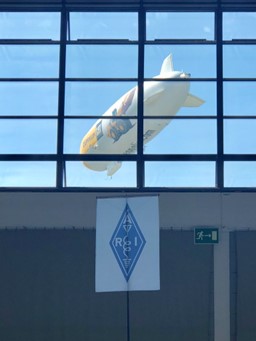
[0,192,256,341]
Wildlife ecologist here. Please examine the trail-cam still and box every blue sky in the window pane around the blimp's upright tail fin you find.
[145,45,216,78]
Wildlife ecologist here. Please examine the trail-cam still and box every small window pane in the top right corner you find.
[223,12,256,40]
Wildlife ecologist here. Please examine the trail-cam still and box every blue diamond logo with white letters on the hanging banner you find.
[109,204,146,282]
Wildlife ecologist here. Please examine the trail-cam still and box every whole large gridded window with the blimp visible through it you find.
[0,6,256,191]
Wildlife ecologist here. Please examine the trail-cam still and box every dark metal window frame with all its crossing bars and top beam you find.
[0,0,256,192]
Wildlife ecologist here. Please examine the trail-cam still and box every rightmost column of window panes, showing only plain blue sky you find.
[223,12,256,188]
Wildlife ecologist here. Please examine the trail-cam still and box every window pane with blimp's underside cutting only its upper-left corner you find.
[144,119,217,154]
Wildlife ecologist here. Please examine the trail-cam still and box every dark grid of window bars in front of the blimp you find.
[0,5,256,192]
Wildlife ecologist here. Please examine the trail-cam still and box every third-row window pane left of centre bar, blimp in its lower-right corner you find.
[65,82,137,116]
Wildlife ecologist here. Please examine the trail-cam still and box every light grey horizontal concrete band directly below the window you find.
[0,192,256,230]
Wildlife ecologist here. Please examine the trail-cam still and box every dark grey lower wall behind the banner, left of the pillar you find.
[0,229,213,341]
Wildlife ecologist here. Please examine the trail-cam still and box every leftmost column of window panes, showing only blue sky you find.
[0,12,60,188]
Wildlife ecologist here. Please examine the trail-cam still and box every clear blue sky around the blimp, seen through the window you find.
[0,12,256,187]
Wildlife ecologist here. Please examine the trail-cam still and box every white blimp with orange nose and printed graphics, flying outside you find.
[80,55,204,176]
